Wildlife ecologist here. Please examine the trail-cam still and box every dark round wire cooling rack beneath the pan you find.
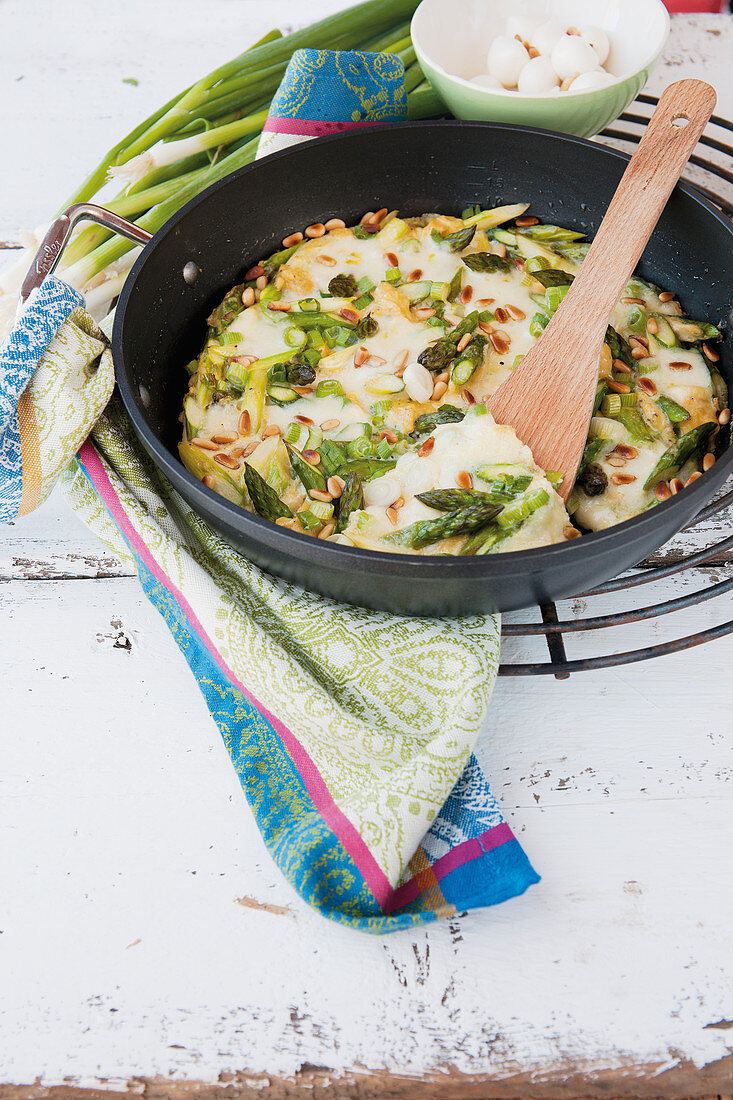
[500,96,733,680]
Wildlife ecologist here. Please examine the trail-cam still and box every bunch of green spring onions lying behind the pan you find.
[0,0,442,332]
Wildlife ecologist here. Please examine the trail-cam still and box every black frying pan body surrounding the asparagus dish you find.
[24,121,733,615]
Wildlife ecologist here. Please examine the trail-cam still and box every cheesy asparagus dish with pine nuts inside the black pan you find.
[179,205,730,554]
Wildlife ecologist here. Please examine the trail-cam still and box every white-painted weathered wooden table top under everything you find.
[0,0,733,1100]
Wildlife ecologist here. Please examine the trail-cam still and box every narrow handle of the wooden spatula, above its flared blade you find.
[568,80,715,318]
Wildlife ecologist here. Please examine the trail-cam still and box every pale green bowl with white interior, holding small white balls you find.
[412,0,669,138]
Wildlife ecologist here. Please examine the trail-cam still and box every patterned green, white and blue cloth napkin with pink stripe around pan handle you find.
[0,53,537,933]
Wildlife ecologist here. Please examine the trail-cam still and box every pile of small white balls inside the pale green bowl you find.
[471,15,615,96]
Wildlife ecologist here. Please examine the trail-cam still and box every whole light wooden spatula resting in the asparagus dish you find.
[489,80,715,499]
